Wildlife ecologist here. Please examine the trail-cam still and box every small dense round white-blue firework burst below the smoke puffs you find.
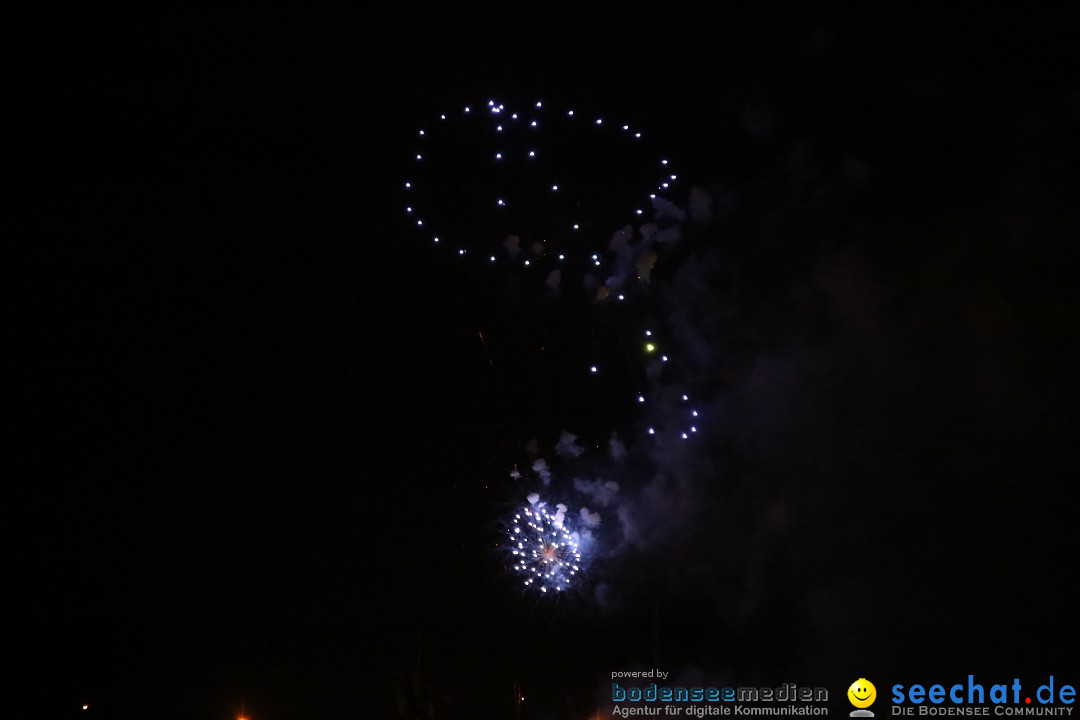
[508,503,581,593]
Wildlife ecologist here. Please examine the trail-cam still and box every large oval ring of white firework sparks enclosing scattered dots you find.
[402,99,675,276]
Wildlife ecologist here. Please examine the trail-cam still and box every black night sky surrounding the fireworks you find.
[8,8,1080,720]
